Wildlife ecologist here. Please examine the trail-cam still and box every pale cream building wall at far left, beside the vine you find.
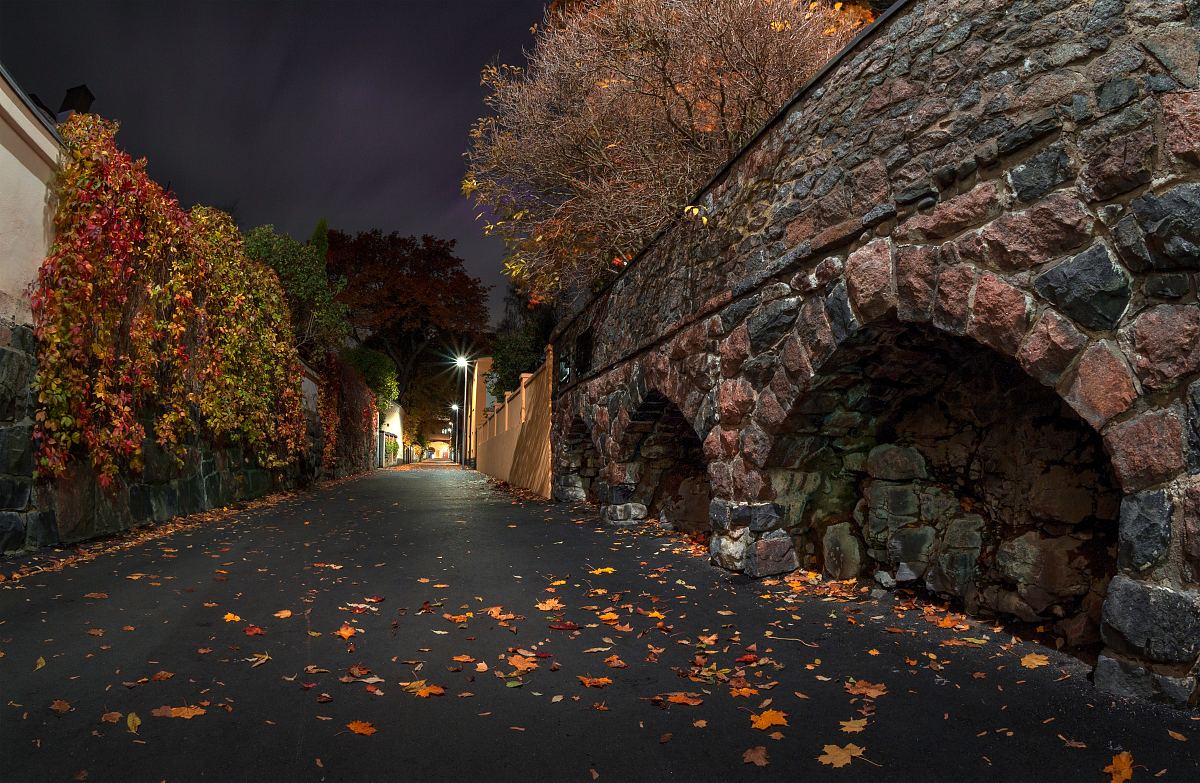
[0,65,61,324]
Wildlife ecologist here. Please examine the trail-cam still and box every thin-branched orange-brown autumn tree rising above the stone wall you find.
[463,0,872,298]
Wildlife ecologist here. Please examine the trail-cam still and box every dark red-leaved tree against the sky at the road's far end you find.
[328,229,487,408]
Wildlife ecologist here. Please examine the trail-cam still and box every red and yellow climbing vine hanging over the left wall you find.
[32,114,304,486]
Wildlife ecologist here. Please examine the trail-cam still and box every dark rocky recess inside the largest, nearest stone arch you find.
[762,317,1121,646]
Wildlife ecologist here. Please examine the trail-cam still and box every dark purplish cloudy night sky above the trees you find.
[0,0,545,318]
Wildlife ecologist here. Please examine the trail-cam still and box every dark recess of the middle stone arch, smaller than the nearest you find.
[602,389,712,532]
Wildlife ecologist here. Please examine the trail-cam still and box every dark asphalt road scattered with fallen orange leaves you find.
[0,468,1200,783]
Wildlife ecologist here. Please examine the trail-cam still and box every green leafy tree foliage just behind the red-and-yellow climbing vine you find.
[246,221,349,364]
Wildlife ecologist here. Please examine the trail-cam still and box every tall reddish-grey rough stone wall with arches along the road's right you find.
[553,0,1200,703]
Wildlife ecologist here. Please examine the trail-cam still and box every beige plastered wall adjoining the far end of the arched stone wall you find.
[476,351,554,497]
